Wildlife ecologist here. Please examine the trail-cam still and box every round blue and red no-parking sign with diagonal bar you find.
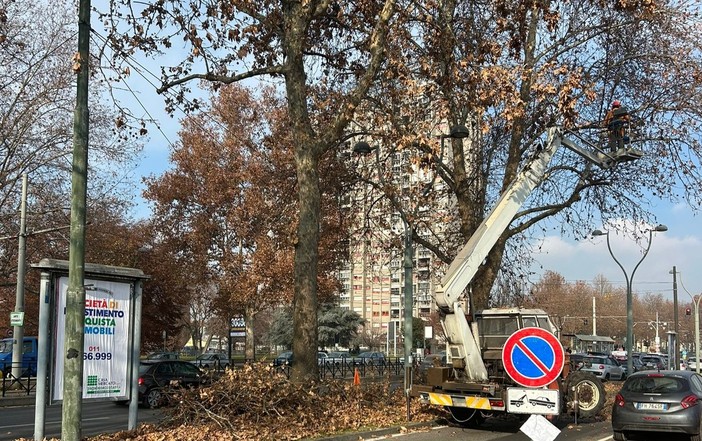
[502,328,565,387]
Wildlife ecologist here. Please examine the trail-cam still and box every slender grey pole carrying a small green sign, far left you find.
[12,173,27,378]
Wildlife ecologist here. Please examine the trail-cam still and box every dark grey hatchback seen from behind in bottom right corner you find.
[612,370,702,441]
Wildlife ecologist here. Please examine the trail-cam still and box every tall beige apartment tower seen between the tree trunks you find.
[340,146,442,353]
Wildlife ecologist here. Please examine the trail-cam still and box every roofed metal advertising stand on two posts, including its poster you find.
[32,259,149,440]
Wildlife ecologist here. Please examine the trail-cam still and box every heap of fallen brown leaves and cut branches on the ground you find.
[28,366,445,441]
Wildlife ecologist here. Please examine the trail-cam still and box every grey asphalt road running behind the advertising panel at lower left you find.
[0,402,160,441]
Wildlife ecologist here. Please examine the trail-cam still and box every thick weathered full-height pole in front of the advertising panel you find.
[63,0,91,441]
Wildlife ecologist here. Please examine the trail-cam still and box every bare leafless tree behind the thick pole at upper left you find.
[0,0,138,321]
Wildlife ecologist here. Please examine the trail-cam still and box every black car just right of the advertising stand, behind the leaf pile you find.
[138,360,208,408]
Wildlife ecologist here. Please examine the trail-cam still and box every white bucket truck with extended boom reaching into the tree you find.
[410,127,643,424]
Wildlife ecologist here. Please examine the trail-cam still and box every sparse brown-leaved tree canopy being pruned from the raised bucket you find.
[358,1,702,308]
